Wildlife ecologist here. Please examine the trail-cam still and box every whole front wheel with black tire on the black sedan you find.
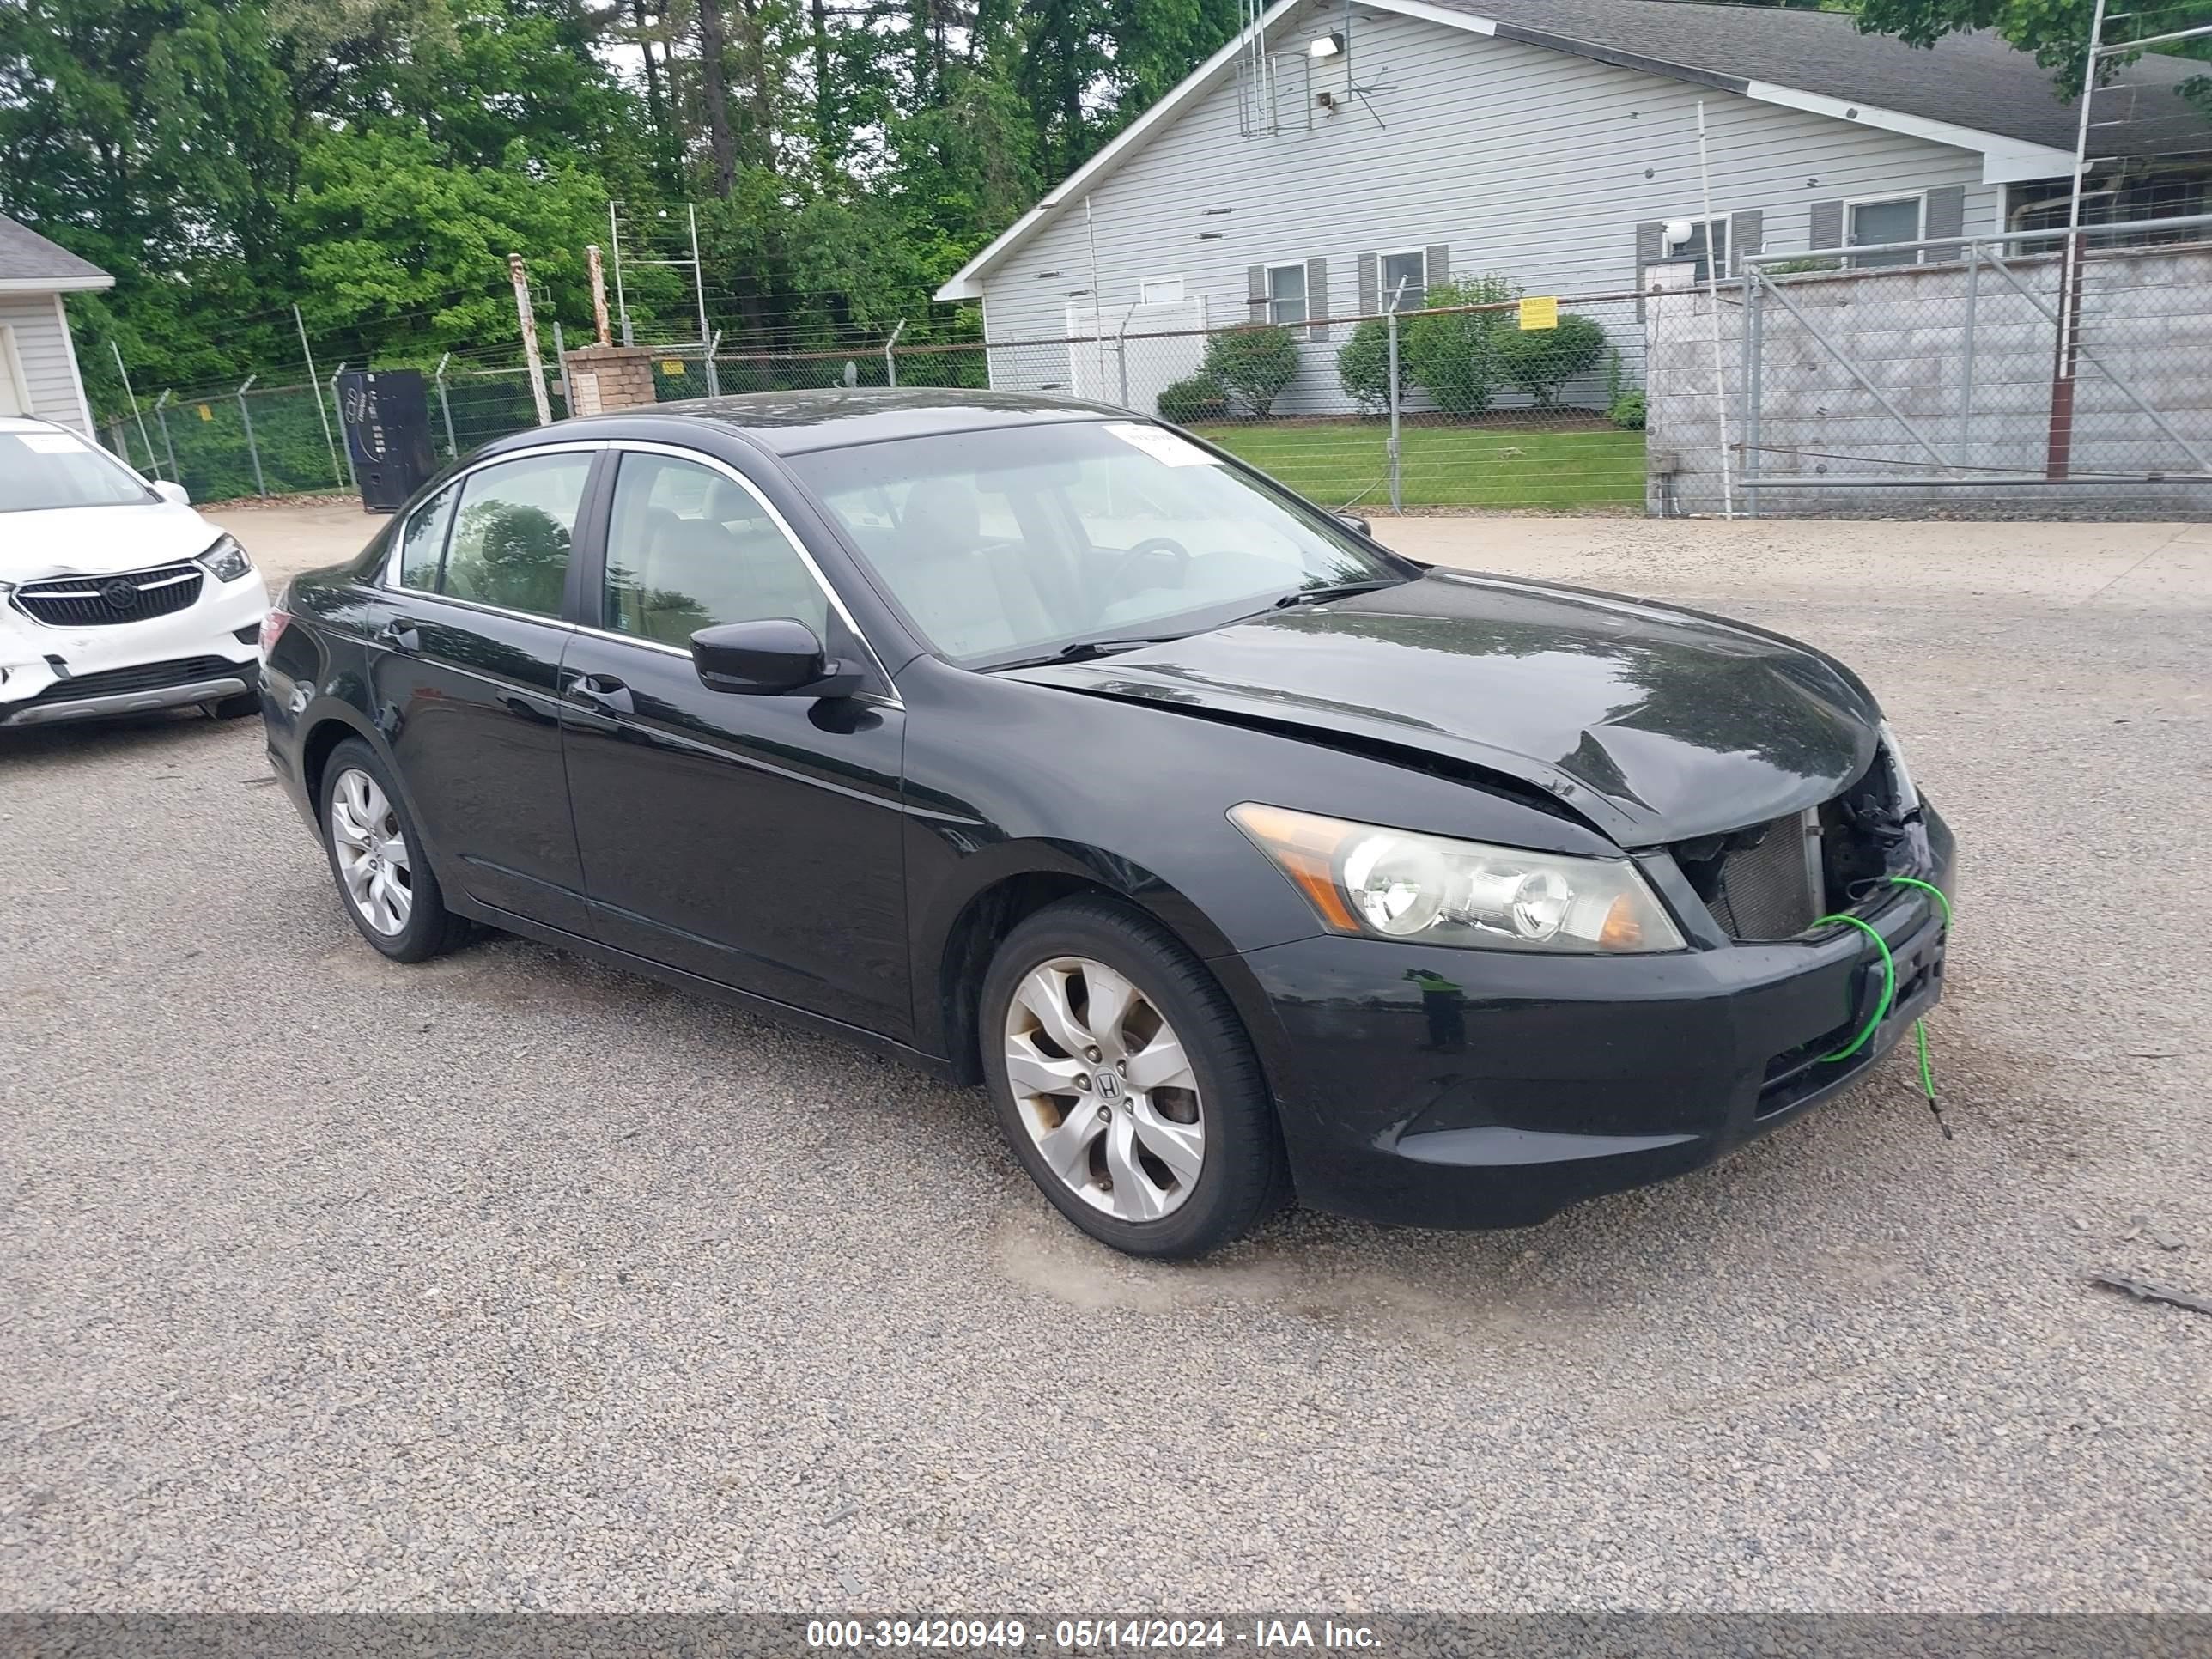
[978,898,1290,1261]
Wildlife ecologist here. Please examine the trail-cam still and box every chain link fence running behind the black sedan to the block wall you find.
[106,272,1644,511]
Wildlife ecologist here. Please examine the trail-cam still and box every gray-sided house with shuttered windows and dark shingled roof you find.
[938,0,2208,411]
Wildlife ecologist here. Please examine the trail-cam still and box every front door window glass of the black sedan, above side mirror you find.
[604,452,830,646]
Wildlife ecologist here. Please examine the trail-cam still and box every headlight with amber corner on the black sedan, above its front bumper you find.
[1230,801,1683,956]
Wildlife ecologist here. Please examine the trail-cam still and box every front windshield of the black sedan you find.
[790,420,1409,668]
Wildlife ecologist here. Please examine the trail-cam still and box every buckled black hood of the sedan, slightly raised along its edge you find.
[1011,571,1881,848]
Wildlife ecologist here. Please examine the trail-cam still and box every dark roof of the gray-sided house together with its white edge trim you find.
[936,0,2212,299]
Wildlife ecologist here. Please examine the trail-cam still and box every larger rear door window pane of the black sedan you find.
[438,452,592,617]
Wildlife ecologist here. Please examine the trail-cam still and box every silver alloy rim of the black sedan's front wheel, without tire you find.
[1005,956,1206,1221]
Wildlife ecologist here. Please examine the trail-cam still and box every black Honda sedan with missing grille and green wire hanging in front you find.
[264,392,1951,1256]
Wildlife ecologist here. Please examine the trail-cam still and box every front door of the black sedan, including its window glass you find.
[562,447,911,1037]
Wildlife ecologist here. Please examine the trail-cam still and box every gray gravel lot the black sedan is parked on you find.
[0,508,2212,1610]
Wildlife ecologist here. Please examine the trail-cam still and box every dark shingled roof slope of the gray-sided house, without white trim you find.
[1431,0,2212,157]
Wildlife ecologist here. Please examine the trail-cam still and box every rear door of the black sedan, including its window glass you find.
[368,445,602,933]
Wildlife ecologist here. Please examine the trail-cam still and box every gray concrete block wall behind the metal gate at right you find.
[1646,243,2212,520]
